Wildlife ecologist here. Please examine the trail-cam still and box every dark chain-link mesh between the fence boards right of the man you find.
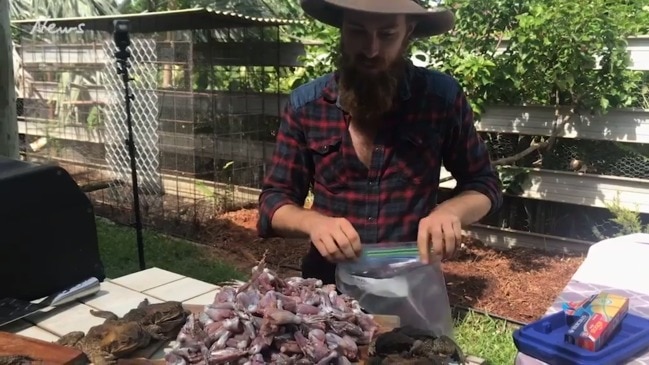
[482,133,649,242]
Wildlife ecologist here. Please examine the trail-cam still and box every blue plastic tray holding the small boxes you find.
[514,311,649,365]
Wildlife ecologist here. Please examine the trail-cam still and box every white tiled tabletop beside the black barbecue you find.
[0,267,218,359]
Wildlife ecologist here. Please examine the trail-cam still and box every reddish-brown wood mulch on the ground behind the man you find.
[199,209,584,322]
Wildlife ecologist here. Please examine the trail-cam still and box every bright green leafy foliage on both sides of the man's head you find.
[300,0,649,114]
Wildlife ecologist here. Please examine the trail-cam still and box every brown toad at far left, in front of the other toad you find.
[56,321,151,365]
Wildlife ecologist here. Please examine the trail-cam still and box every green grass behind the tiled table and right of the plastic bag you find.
[97,219,516,365]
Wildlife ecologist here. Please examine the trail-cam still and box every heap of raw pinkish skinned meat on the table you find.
[165,260,378,365]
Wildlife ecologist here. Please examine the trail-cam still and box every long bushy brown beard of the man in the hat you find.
[337,41,405,128]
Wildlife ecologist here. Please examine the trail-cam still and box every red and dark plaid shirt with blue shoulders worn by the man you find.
[257,64,502,243]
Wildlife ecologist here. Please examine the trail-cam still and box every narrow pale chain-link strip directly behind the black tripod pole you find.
[102,38,164,206]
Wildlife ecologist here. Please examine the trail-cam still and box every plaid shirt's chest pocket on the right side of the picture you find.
[392,128,442,187]
